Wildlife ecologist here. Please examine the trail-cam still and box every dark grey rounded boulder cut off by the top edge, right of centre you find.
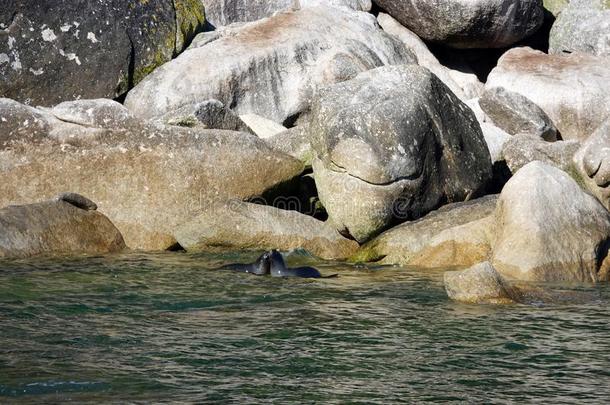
[375,0,544,48]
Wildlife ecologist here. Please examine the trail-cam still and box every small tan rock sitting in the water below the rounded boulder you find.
[444,262,514,304]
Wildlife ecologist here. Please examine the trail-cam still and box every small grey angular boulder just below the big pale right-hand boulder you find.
[479,87,557,141]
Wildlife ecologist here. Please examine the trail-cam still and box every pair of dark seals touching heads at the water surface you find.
[220,250,338,278]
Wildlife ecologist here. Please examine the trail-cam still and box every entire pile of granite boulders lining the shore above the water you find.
[0,0,610,302]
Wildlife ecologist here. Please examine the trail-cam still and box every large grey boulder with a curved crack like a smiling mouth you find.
[308,65,491,242]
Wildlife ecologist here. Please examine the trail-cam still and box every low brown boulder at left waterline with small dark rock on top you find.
[0,200,126,258]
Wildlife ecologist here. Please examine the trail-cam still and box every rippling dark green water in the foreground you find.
[0,253,610,404]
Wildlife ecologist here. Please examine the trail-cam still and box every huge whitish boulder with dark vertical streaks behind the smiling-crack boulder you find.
[125,7,416,123]
